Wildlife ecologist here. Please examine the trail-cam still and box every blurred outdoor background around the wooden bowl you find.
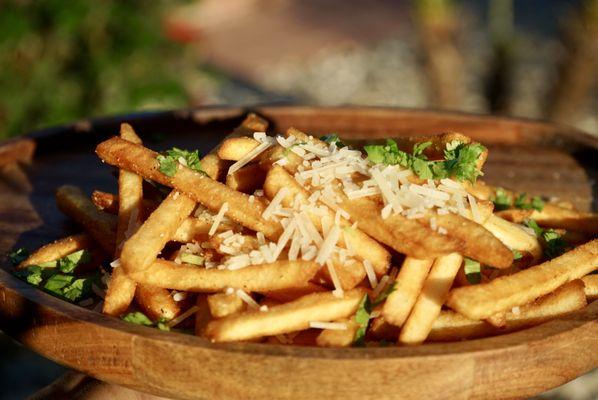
[0,0,598,399]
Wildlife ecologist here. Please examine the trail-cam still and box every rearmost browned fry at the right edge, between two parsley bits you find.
[498,204,598,235]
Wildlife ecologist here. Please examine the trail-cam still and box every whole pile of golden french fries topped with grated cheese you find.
[10,114,598,347]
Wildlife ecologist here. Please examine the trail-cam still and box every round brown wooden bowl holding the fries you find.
[0,107,598,399]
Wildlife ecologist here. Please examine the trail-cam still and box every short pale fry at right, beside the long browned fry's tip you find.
[484,215,543,261]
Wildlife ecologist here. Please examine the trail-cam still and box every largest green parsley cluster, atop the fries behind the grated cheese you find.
[364,139,486,182]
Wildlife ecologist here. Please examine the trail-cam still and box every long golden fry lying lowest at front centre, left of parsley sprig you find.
[206,289,365,342]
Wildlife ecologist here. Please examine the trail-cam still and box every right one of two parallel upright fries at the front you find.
[399,253,463,345]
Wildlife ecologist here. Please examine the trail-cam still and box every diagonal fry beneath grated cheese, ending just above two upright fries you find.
[264,166,390,275]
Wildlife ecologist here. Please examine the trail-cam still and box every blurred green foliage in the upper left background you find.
[0,0,187,138]
